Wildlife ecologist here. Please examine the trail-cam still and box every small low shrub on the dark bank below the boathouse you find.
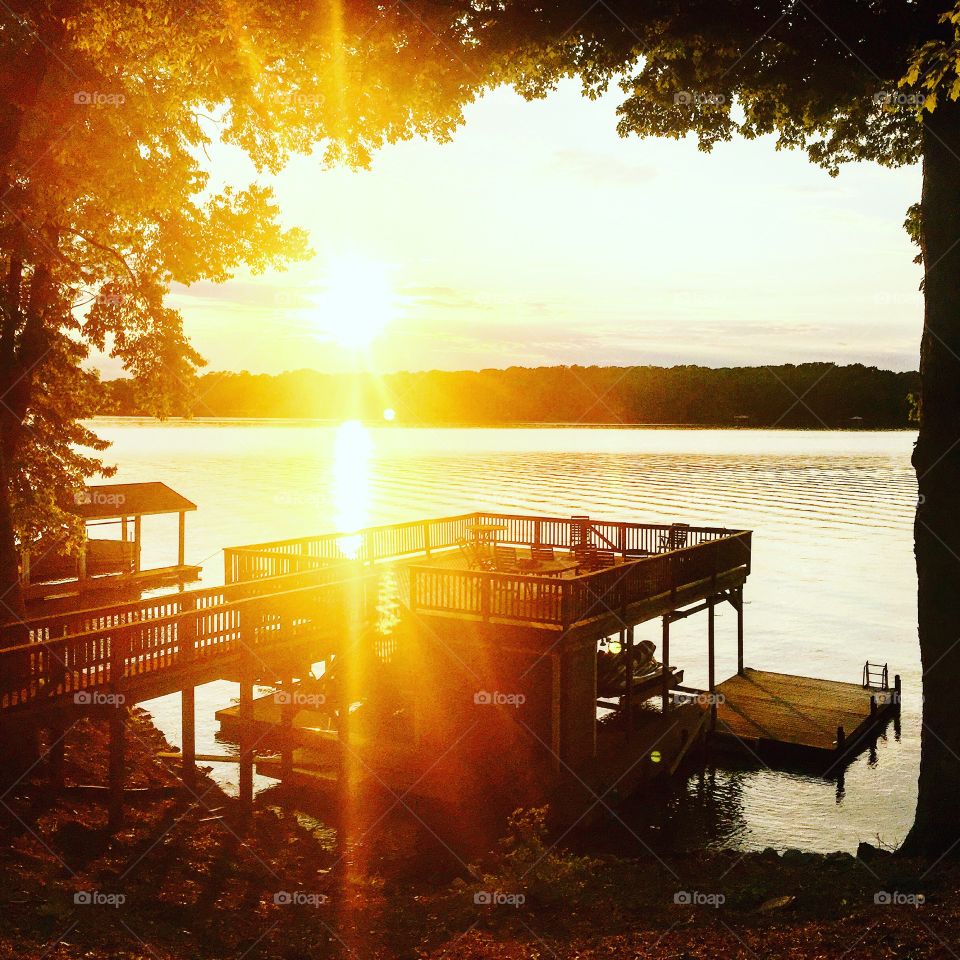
[477,807,598,906]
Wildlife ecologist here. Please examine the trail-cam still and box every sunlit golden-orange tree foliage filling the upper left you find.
[0,0,492,560]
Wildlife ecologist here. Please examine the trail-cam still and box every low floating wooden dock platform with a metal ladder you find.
[715,668,899,756]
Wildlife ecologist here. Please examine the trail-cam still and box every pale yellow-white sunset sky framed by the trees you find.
[168,81,922,373]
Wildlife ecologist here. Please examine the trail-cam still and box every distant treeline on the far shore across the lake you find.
[101,363,919,428]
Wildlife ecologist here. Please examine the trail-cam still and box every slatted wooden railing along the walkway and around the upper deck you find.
[0,513,751,709]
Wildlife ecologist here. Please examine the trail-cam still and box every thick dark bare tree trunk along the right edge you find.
[903,101,960,856]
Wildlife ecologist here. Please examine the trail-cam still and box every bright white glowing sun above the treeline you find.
[316,256,397,350]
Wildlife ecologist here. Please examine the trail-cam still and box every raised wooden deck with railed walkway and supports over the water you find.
[0,513,751,823]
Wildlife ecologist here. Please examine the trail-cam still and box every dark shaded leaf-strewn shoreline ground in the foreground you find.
[0,710,948,960]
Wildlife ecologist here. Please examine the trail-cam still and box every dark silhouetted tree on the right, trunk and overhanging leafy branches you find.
[446,0,960,853]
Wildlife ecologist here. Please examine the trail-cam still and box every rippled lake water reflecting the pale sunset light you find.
[93,419,920,851]
